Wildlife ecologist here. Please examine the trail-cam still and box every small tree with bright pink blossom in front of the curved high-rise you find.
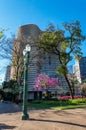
[33,74,59,98]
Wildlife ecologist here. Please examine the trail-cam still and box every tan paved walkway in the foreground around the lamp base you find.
[0,102,86,130]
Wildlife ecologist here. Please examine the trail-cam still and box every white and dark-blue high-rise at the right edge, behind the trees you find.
[73,57,86,83]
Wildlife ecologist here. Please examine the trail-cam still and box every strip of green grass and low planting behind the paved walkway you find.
[28,98,86,109]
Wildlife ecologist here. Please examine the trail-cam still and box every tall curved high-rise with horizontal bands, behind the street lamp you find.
[11,24,68,99]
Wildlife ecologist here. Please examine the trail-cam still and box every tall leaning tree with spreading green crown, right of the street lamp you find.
[38,21,85,98]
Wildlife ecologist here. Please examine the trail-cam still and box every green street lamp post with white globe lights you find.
[22,44,31,120]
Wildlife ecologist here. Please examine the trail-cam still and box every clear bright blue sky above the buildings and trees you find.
[0,0,86,82]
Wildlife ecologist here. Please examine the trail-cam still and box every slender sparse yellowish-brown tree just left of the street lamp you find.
[11,39,24,86]
